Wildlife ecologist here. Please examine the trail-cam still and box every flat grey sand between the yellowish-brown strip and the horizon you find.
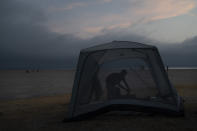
[0,69,197,100]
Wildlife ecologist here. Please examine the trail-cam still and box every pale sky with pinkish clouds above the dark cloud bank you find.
[42,0,197,42]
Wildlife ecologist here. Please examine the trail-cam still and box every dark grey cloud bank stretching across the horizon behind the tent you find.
[0,0,197,69]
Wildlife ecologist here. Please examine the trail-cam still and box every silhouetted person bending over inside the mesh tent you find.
[106,70,130,99]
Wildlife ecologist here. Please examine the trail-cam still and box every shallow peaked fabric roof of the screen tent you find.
[82,41,156,52]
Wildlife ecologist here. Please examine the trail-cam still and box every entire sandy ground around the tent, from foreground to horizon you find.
[0,70,197,131]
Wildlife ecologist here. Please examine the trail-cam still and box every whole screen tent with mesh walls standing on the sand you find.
[67,41,183,120]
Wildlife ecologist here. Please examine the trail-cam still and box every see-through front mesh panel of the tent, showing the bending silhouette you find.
[77,49,173,105]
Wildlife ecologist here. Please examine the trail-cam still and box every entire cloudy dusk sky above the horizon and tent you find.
[0,0,197,69]
